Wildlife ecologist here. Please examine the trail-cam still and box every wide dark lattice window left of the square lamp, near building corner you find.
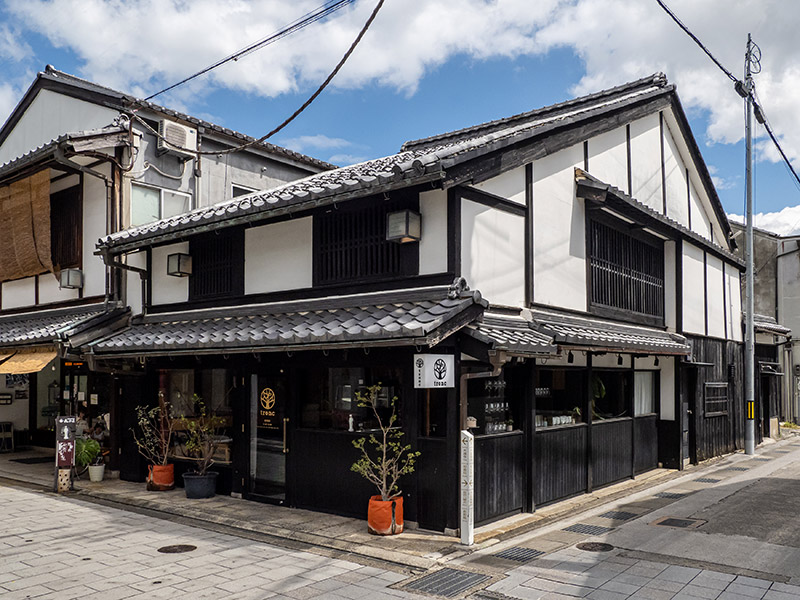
[314,202,403,285]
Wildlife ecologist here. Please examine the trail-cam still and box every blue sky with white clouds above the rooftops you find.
[0,0,800,233]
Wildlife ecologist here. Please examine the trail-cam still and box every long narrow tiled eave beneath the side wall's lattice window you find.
[532,310,691,355]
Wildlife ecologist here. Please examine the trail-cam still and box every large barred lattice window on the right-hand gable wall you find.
[588,220,664,320]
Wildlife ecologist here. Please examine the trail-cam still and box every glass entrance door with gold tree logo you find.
[250,374,289,504]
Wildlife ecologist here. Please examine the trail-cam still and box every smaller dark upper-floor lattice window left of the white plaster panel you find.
[189,229,244,300]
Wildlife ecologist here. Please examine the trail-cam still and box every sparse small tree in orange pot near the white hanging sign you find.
[350,383,420,535]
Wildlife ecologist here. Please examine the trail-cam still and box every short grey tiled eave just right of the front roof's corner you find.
[464,313,558,355]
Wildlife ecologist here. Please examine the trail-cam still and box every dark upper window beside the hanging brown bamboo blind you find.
[50,186,83,271]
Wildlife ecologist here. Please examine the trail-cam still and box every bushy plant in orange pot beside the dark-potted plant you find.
[131,392,175,491]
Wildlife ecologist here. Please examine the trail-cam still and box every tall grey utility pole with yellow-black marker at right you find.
[744,33,756,454]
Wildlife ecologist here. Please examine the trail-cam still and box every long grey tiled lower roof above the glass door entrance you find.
[91,288,488,356]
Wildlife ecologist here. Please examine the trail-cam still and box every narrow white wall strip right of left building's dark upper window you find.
[83,165,110,296]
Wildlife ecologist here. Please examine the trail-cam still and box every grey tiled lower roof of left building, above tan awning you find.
[0,304,104,348]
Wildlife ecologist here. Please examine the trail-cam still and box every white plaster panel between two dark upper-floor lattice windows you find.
[244,217,313,294]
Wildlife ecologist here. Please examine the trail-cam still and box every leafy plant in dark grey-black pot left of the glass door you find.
[181,394,222,498]
